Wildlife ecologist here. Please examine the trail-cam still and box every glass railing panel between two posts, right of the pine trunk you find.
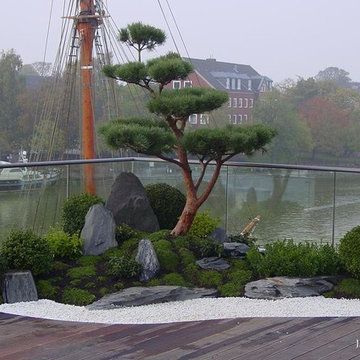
[228,168,333,244]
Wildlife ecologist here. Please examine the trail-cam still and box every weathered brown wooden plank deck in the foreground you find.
[0,313,360,360]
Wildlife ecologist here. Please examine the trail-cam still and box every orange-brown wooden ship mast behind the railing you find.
[77,0,98,194]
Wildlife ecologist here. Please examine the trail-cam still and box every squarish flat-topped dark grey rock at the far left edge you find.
[2,271,38,304]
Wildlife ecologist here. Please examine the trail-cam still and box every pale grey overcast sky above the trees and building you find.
[0,0,360,82]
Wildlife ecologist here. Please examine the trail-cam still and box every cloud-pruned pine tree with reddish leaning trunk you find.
[100,25,275,236]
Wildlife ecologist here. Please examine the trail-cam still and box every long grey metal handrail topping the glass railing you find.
[0,157,360,173]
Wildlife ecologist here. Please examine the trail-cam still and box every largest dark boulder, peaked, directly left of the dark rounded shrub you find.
[105,172,159,233]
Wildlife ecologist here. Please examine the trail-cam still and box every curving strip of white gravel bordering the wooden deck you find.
[0,297,360,324]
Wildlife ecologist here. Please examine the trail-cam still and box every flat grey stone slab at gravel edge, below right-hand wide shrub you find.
[244,276,338,300]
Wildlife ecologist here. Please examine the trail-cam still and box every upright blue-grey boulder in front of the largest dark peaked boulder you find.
[80,204,118,255]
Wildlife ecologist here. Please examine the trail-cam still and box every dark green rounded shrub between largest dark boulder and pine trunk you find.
[145,183,186,229]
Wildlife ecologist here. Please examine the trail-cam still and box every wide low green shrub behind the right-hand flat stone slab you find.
[246,240,340,277]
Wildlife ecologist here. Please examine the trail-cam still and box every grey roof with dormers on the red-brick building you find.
[184,58,272,92]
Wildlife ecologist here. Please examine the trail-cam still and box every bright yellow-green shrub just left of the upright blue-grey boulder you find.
[45,225,83,260]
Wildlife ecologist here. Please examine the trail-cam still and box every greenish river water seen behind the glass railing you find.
[0,162,360,244]
